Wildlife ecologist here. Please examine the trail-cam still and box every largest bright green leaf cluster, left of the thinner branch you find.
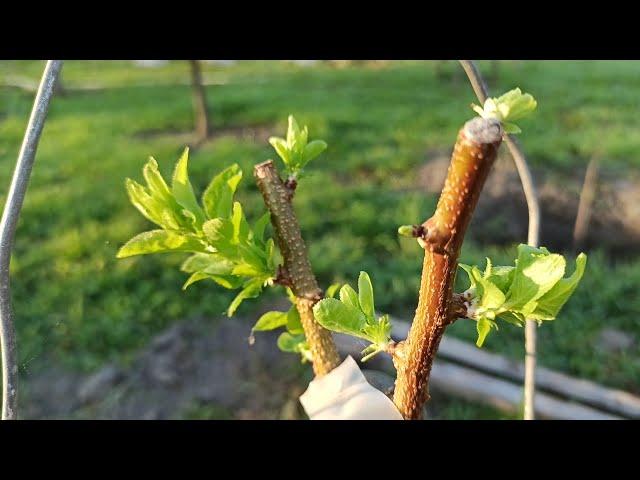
[117,148,275,316]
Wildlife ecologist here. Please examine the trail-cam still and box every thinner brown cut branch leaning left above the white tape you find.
[254,160,340,376]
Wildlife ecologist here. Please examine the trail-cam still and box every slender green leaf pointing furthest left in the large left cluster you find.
[117,230,206,258]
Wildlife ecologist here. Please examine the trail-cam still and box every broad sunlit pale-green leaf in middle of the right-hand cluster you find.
[506,245,566,311]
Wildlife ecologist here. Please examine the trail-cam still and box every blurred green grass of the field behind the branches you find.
[0,61,640,416]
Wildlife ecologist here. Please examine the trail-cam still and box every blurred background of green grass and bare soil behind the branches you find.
[0,61,640,419]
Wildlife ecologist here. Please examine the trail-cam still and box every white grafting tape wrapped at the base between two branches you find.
[300,356,402,420]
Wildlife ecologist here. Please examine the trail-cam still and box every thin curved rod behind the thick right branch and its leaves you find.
[460,60,540,420]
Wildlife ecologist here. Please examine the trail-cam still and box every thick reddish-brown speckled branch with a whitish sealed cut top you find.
[393,117,503,419]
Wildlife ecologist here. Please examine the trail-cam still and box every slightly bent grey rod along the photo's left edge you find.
[0,60,62,420]
